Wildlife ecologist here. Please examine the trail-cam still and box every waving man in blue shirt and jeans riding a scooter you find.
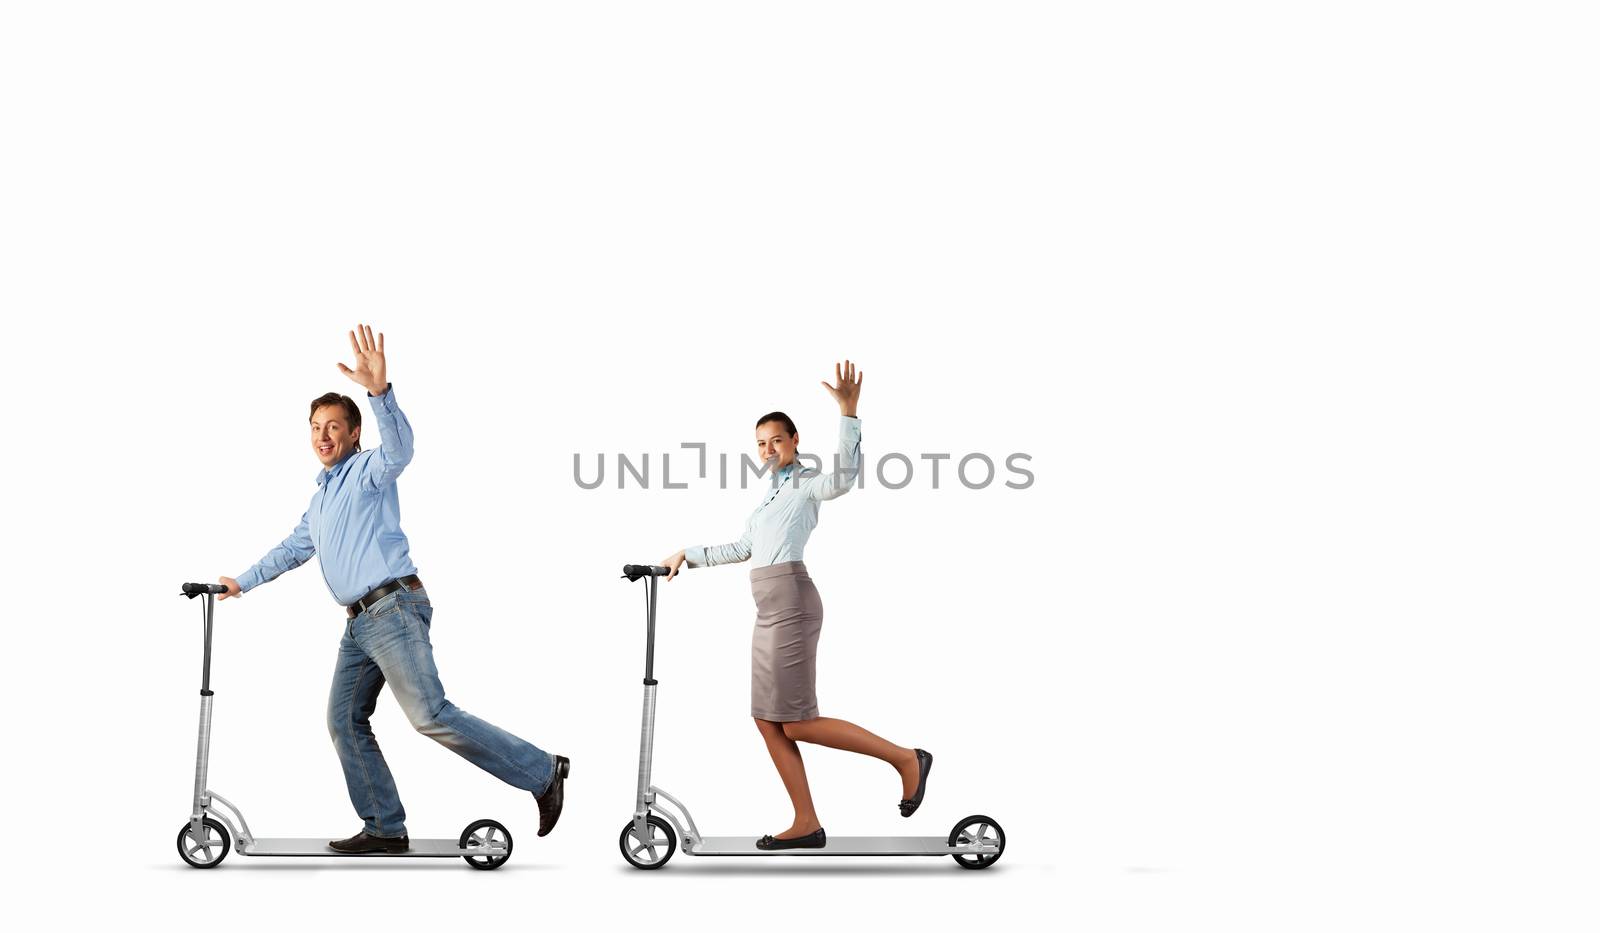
[218,325,571,853]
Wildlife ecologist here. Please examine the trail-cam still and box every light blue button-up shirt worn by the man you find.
[238,384,416,605]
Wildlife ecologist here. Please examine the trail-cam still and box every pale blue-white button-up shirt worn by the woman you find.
[683,414,861,568]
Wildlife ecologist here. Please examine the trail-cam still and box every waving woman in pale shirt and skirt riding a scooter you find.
[661,360,933,850]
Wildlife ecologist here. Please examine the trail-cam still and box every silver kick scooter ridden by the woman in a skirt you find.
[618,563,1005,869]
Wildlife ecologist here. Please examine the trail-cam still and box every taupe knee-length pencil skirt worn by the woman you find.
[750,560,822,722]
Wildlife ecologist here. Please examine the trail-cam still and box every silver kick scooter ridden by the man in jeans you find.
[178,583,510,871]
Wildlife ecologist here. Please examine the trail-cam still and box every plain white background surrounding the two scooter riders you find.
[0,2,1600,930]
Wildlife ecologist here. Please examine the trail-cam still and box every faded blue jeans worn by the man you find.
[328,589,555,837]
